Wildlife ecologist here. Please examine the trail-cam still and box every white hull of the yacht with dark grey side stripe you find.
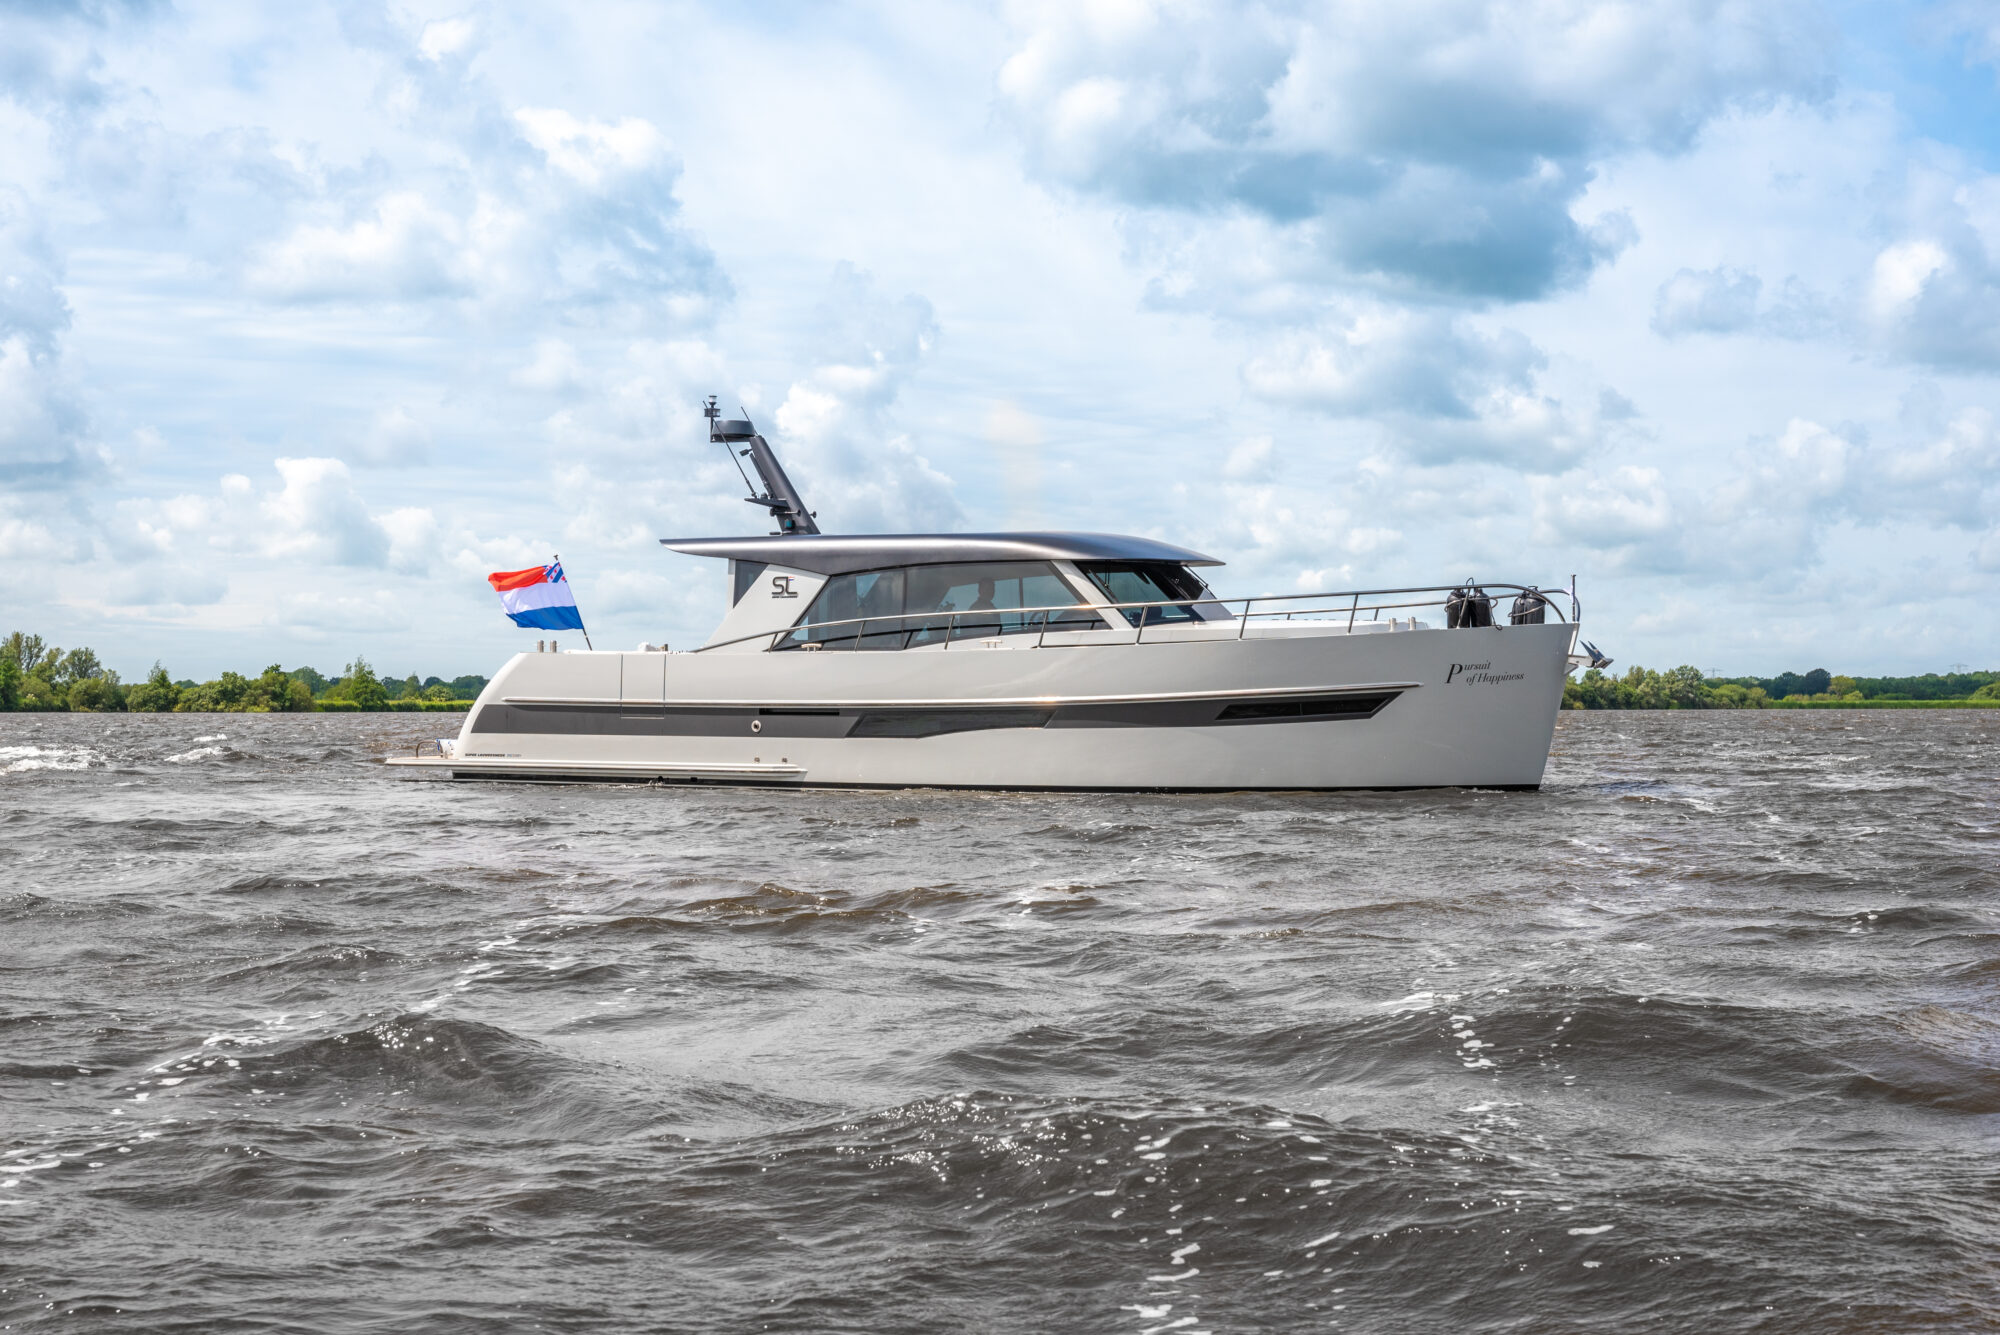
[392,622,1574,789]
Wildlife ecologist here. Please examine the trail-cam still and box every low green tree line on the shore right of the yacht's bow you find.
[1562,668,2000,709]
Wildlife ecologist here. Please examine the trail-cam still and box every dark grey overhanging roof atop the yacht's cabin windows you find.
[660,534,1222,576]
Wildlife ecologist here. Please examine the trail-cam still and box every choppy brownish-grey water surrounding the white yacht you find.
[0,711,2000,1335]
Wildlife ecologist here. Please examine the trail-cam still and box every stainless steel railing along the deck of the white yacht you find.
[694,584,1576,654]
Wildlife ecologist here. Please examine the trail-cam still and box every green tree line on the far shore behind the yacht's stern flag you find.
[0,632,486,713]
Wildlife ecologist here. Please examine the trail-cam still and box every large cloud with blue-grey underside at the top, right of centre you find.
[1000,0,1832,300]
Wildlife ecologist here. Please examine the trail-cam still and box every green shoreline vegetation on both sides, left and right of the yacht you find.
[0,632,2000,713]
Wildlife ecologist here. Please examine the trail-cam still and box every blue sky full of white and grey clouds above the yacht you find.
[0,0,2000,679]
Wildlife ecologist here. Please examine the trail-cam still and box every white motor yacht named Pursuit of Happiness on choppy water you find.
[390,400,1608,791]
